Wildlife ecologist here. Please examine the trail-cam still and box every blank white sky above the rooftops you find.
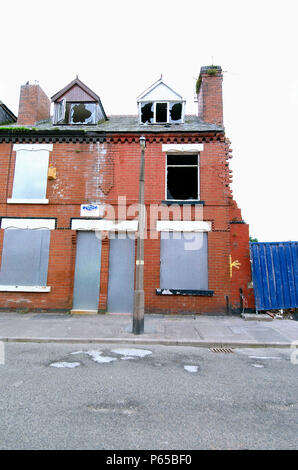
[0,0,298,241]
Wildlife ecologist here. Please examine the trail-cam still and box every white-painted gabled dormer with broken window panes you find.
[138,79,185,124]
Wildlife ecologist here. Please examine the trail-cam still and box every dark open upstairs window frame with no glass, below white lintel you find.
[166,155,199,201]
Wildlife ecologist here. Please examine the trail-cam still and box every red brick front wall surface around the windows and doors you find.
[0,135,253,313]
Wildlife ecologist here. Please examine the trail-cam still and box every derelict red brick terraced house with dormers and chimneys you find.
[0,66,254,313]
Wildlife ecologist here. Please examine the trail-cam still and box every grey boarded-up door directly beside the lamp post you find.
[108,234,135,313]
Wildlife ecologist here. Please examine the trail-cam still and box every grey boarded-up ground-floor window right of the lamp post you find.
[160,232,208,290]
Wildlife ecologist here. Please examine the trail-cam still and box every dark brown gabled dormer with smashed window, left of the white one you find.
[52,78,107,125]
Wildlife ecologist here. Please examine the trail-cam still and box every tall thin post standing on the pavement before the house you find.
[132,136,146,335]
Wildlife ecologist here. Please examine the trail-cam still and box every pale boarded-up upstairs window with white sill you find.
[12,150,49,199]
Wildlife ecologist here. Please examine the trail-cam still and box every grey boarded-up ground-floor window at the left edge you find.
[0,229,50,286]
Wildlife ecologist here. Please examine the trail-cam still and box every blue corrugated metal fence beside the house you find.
[250,242,298,310]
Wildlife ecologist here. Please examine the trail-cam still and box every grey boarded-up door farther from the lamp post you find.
[72,232,101,310]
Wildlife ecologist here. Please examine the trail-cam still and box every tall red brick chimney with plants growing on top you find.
[196,65,223,126]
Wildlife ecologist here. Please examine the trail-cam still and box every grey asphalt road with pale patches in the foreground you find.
[0,343,298,450]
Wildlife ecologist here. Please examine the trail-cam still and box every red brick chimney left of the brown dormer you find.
[17,84,51,126]
